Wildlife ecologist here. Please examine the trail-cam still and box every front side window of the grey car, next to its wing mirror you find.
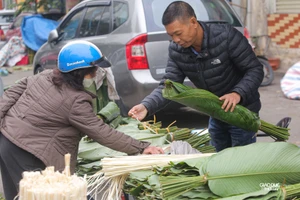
[58,9,85,40]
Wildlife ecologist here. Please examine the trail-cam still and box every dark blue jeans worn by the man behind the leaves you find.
[208,117,256,152]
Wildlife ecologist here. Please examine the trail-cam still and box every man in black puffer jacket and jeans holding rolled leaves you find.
[128,1,263,151]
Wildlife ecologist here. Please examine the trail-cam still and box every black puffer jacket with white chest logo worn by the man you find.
[142,22,263,115]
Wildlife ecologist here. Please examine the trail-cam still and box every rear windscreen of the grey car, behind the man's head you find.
[143,0,241,32]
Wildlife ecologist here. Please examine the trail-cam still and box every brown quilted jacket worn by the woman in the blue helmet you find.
[0,70,150,172]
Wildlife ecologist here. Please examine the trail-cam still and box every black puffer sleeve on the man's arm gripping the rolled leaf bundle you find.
[228,26,264,105]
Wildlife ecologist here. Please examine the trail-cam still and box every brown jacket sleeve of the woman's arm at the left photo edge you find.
[0,77,27,120]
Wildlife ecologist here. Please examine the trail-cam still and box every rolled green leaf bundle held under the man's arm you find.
[162,80,290,140]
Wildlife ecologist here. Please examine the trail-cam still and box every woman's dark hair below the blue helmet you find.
[52,66,98,90]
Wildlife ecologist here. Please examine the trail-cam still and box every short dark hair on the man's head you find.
[162,1,197,26]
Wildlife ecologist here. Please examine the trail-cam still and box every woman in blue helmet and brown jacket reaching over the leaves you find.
[0,41,163,200]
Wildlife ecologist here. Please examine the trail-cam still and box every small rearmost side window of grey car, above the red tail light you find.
[113,1,128,30]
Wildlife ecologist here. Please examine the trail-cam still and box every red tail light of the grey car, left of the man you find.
[126,34,149,70]
